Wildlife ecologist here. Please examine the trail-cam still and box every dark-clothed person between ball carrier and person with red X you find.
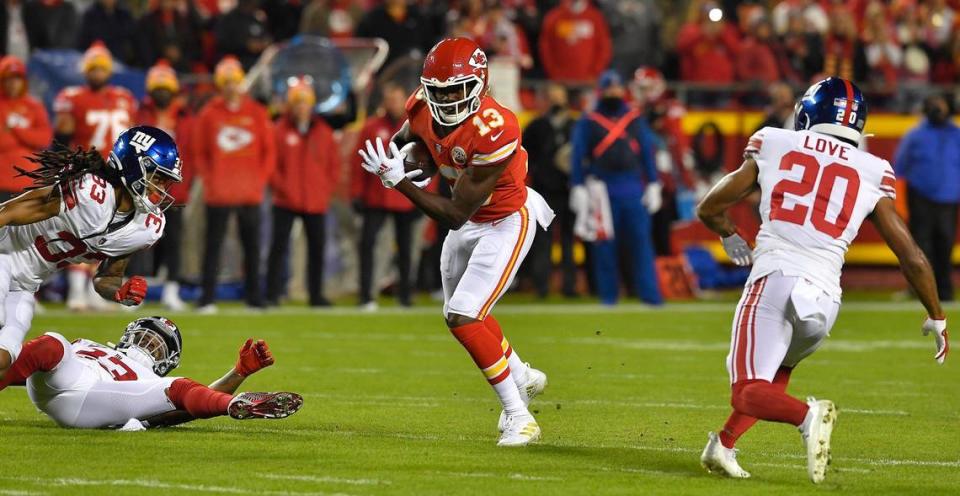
[523,84,577,298]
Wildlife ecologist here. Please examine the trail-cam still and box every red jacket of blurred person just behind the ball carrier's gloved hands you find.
[350,115,414,212]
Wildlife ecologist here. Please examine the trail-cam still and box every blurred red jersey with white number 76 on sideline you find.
[53,86,137,159]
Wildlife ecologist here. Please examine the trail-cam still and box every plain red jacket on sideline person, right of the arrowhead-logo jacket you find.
[270,117,340,214]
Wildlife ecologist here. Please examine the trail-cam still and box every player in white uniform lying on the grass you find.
[0,317,303,430]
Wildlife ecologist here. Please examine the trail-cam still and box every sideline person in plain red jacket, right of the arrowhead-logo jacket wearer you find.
[267,77,340,307]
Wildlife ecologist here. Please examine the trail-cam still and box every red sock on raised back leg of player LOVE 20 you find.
[732,370,810,426]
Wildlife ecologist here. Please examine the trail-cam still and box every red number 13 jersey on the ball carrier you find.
[407,88,527,223]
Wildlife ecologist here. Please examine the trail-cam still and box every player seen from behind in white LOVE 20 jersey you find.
[697,78,949,483]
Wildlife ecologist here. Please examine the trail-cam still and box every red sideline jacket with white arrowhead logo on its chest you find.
[191,96,277,207]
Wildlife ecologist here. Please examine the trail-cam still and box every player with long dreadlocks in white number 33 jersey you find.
[0,126,182,376]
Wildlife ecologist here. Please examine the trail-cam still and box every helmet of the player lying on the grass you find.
[117,317,183,377]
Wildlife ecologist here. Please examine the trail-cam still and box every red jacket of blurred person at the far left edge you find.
[0,94,53,193]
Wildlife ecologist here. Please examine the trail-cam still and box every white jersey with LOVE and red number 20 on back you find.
[744,127,896,301]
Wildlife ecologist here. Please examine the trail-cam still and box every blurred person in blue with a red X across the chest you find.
[570,71,663,305]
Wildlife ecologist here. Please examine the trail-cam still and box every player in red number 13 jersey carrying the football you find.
[360,38,553,446]
